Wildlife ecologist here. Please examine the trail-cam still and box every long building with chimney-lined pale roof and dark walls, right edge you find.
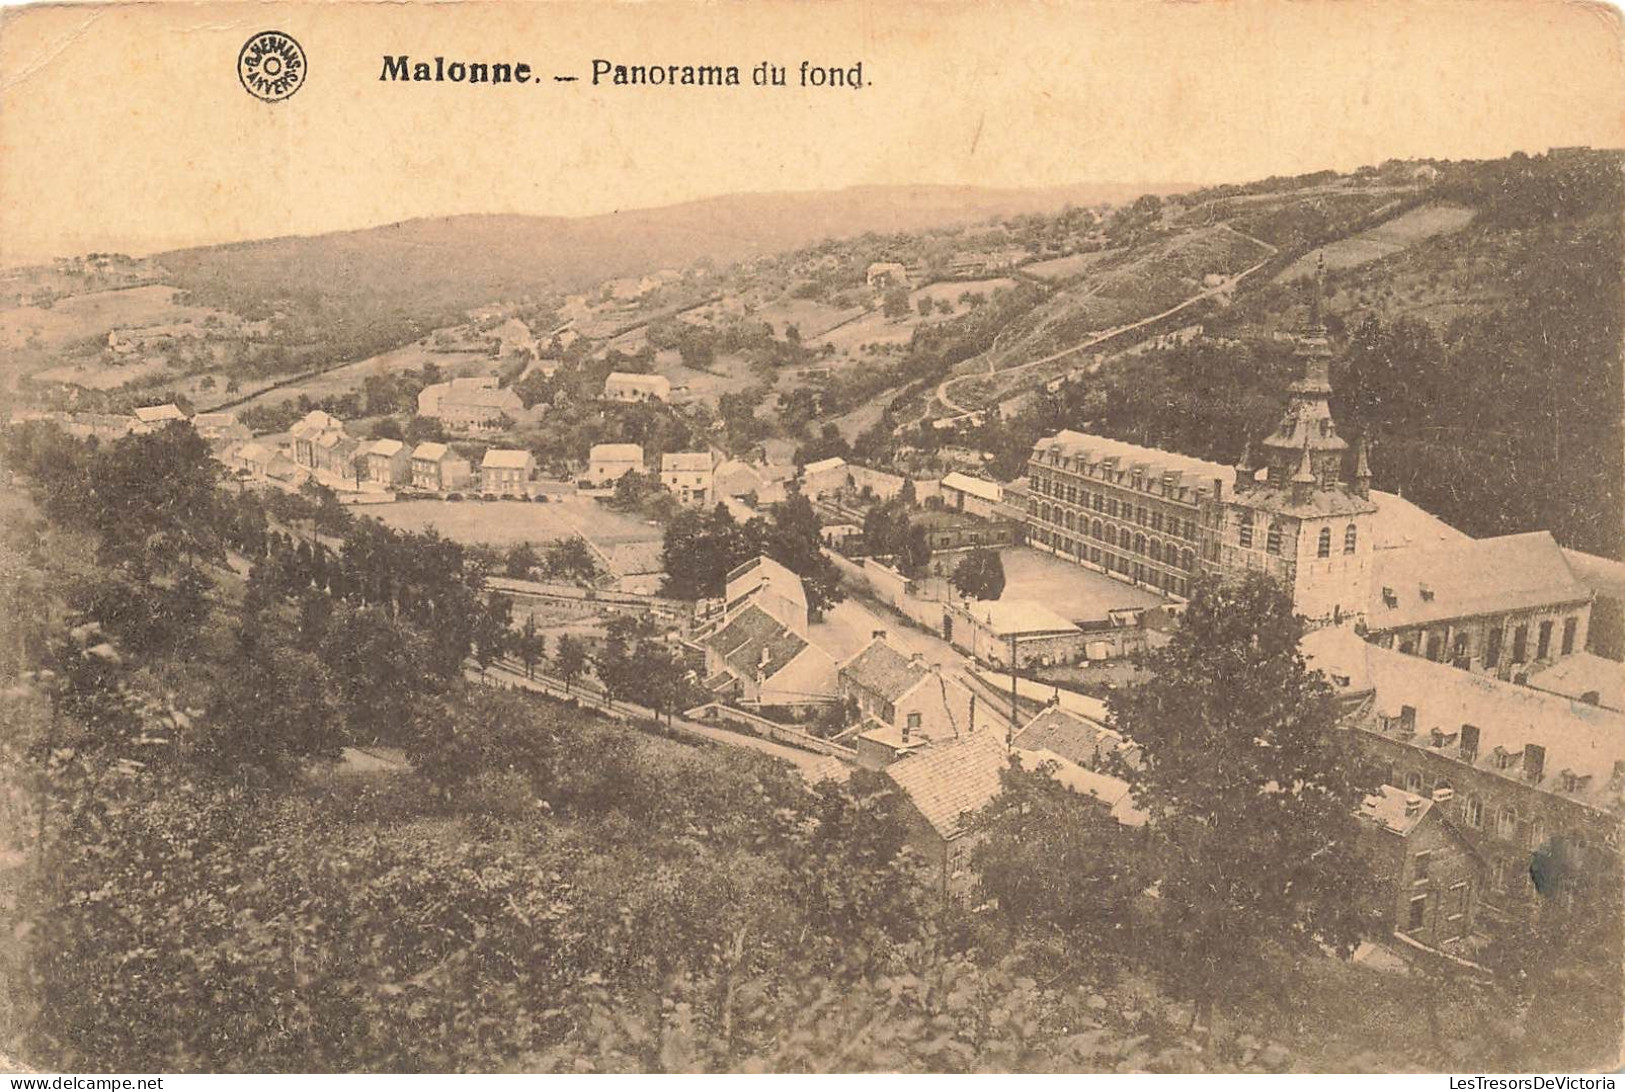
[1303,627,1625,925]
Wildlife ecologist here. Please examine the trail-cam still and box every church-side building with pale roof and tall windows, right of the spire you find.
[1365,531,1593,679]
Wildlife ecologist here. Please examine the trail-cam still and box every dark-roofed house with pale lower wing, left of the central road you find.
[704,601,835,705]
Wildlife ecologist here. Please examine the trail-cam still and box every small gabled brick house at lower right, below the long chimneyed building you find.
[1359,785,1484,952]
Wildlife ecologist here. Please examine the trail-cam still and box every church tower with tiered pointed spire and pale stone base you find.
[1219,260,1376,624]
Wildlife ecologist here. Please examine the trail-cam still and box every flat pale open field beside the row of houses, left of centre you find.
[366,497,661,553]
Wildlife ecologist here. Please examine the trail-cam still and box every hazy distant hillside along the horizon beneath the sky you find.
[154,184,1180,351]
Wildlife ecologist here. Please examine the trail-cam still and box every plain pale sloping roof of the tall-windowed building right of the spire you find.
[1365,531,1591,631]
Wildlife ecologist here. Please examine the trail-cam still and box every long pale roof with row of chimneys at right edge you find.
[1302,626,1625,809]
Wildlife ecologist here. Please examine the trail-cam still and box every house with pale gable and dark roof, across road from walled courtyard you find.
[839,635,975,770]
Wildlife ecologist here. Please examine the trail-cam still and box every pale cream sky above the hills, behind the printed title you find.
[0,0,1625,263]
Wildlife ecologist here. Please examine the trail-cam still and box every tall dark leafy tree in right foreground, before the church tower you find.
[1110,574,1375,1019]
